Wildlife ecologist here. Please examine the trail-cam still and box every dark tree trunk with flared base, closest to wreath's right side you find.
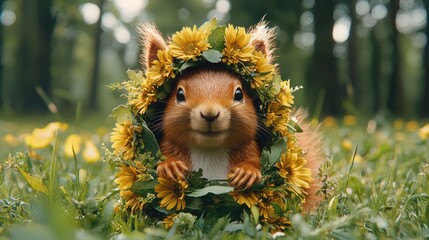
[305,0,345,116]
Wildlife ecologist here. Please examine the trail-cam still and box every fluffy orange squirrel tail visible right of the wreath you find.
[292,108,325,213]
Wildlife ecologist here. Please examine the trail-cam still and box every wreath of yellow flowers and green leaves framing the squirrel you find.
[111,19,312,231]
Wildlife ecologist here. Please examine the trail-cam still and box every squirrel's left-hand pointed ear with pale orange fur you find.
[138,23,167,69]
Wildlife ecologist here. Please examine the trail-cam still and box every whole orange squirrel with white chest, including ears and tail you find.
[139,21,323,209]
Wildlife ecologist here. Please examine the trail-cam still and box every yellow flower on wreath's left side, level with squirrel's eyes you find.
[130,79,157,115]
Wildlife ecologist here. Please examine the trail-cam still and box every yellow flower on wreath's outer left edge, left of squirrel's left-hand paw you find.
[114,162,144,191]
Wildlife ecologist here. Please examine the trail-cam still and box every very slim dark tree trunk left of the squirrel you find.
[89,0,105,111]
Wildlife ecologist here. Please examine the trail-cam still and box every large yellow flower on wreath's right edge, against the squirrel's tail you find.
[276,137,312,188]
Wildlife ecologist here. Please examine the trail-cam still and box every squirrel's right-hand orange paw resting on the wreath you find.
[228,167,262,189]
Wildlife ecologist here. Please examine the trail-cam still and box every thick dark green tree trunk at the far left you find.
[9,0,54,113]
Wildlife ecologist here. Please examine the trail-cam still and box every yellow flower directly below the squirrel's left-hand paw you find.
[155,177,188,211]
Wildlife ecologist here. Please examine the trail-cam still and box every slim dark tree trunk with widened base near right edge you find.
[387,0,406,116]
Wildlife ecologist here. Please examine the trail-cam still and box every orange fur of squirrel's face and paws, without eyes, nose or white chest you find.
[158,68,261,187]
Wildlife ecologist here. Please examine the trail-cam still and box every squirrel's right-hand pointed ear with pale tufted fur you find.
[250,19,276,63]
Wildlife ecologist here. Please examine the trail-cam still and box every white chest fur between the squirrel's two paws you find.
[191,149,229,180]
